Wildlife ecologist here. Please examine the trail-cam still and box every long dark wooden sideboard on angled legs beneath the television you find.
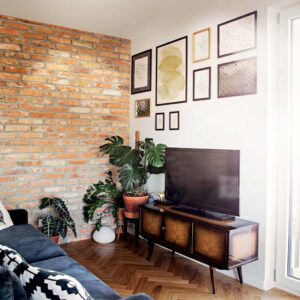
[140,205,259,293]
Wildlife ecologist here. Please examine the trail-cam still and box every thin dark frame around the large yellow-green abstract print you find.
[155,36,188,106]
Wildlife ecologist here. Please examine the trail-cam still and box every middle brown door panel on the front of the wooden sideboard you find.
[164,216,192,250]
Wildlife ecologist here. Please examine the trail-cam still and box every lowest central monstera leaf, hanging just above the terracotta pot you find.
[119,164,147,191]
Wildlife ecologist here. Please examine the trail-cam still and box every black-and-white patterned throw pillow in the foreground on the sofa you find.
[0,244,93,300]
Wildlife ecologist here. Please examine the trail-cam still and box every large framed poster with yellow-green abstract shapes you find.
[155,36,187,105]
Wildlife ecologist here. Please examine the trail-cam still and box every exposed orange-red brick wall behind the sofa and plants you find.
[0,16,130,239]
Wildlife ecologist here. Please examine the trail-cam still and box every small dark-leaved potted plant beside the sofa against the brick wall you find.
[39,197,77,243]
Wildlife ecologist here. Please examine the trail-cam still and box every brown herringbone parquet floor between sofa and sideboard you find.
[62,240,299,300]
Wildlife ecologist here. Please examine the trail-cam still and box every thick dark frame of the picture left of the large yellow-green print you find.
[131,49,152,94]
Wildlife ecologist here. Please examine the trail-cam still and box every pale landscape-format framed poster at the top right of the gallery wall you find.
[218,11,257,57]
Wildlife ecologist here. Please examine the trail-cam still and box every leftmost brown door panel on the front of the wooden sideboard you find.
[142,209,163,238]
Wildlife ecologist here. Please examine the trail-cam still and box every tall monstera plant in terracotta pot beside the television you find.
[99,136,166,218]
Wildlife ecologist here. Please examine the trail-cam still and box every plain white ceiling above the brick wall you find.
[0,0,211,40]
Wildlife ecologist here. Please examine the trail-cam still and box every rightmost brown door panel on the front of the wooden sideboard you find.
[194,224,226,265]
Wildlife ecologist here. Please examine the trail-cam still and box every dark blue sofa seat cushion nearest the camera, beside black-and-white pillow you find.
[32,256,120,300]
